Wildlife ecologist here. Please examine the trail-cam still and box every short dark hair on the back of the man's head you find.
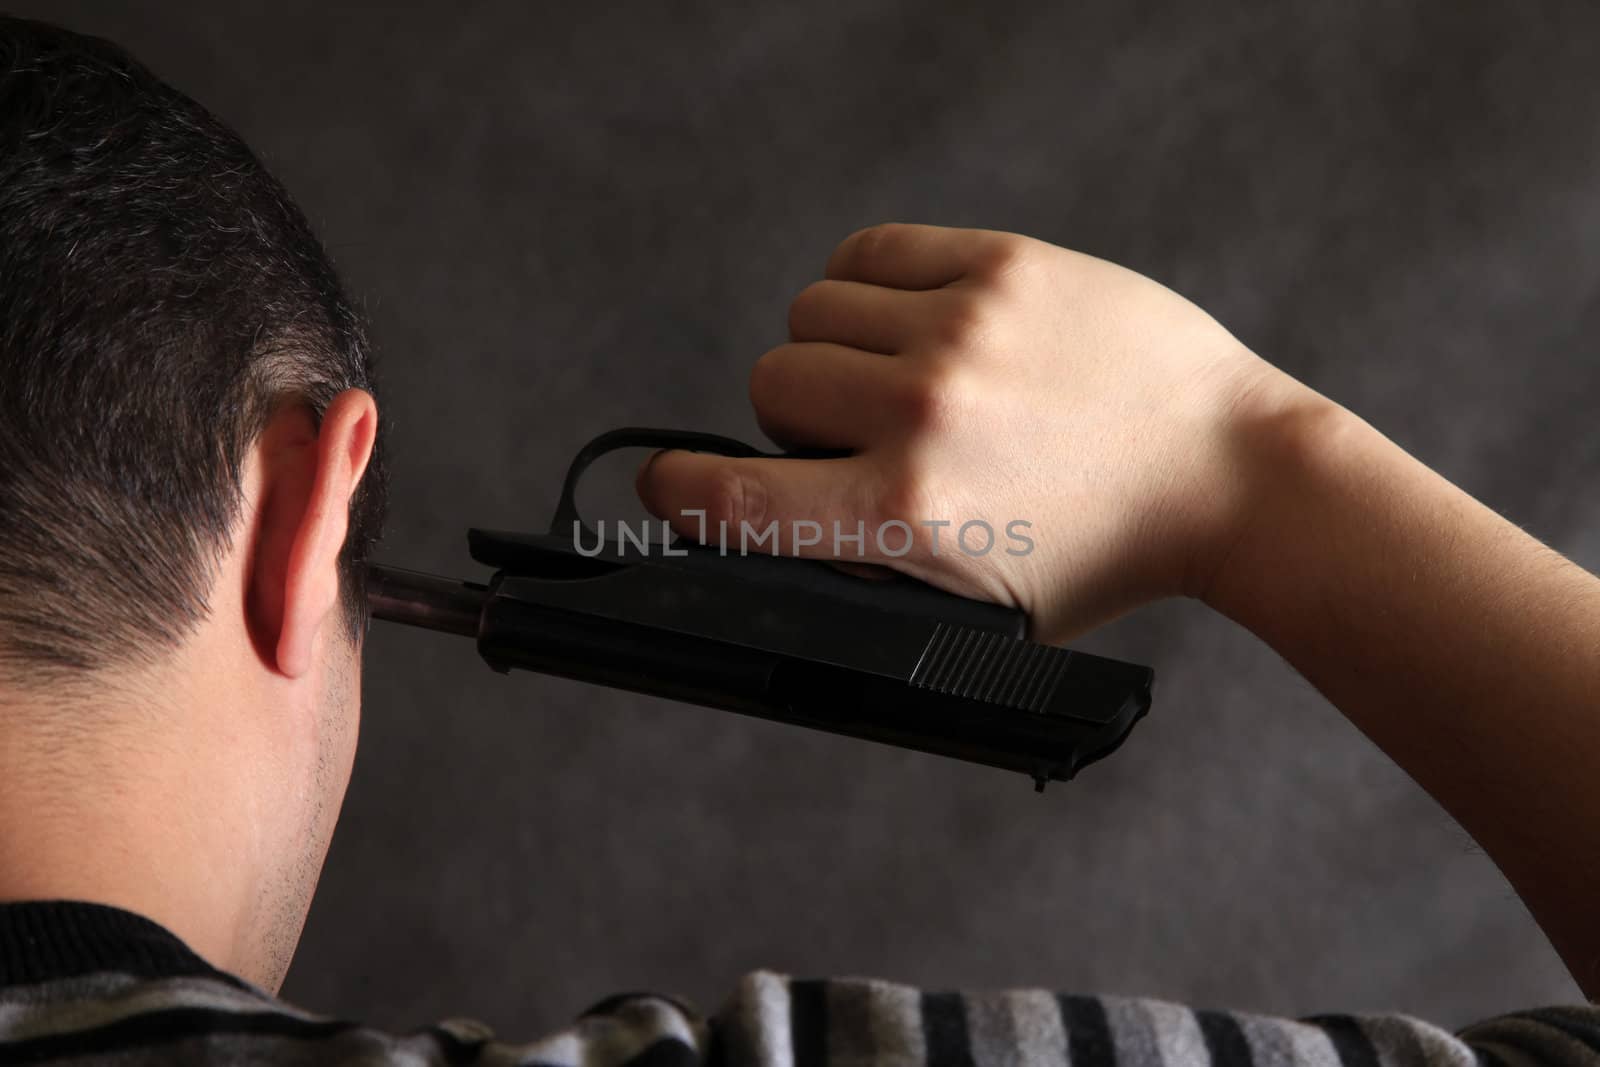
[0,18,386,680]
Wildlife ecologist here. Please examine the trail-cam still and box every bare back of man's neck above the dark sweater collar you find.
[0,675,278,982]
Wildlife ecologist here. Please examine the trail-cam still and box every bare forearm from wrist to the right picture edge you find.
[1205,379,1600,998]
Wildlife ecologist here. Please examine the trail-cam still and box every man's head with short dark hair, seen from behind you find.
[0,18,384,981]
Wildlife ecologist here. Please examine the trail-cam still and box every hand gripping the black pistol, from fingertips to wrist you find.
[638,224,1320,641]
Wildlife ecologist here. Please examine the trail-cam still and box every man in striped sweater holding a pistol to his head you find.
[0,19,1600,1067]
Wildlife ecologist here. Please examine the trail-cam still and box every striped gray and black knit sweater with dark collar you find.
[0,902,1600,1067]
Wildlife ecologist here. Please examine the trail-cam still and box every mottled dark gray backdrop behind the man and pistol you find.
[21,0,1600,1037]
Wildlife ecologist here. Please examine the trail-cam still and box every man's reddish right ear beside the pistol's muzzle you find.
[245,389,378,678]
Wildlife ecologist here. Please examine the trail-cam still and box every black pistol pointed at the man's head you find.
[368,427,1155,790]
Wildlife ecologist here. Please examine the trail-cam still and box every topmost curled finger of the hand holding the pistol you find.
[824,222,1018,290]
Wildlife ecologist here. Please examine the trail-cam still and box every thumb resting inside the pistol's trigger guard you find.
[635,450,875,560]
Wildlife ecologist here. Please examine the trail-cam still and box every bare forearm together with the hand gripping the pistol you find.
[638,224,1600,998]
